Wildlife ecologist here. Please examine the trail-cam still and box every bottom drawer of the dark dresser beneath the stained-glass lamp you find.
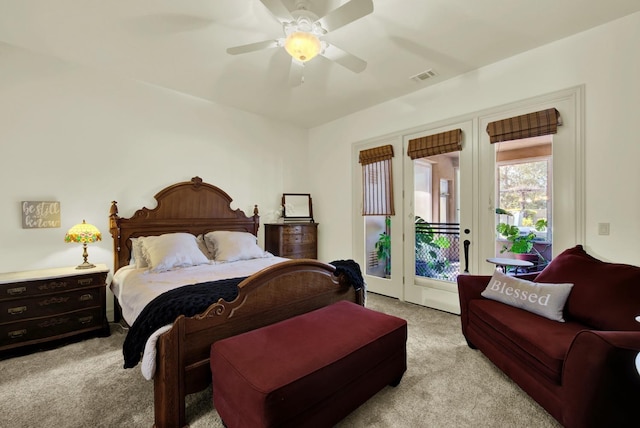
[0,308,103,349]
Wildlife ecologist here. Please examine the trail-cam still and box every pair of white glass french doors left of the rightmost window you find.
[353,120,476,313]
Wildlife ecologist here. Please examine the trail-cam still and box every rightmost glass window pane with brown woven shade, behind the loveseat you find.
[487,108,562,270]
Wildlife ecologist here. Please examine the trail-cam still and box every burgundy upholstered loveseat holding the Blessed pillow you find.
[458,245,640,428]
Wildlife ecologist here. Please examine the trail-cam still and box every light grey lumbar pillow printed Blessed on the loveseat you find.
[481,270,573,322]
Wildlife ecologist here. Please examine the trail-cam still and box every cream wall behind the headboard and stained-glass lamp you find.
[0,44,309,272]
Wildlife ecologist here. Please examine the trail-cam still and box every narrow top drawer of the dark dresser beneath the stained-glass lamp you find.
[0,272,107,300]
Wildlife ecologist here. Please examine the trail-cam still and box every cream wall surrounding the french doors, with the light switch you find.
[309,13,640,265]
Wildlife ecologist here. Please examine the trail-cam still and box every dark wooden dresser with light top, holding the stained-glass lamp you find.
[0,265,109,355]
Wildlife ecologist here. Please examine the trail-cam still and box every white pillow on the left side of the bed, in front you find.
[139,233,209,272]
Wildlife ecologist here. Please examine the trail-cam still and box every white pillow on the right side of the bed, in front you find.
[204,230,268,262]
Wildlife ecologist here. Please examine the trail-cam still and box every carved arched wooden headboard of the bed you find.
[109,177,260,272]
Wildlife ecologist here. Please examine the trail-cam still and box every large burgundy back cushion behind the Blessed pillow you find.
[535,245,640,331]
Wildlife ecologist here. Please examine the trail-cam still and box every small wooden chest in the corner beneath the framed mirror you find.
[264,223,318,259]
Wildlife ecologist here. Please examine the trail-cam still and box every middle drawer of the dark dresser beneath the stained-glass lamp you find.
[0,287,103,324]
